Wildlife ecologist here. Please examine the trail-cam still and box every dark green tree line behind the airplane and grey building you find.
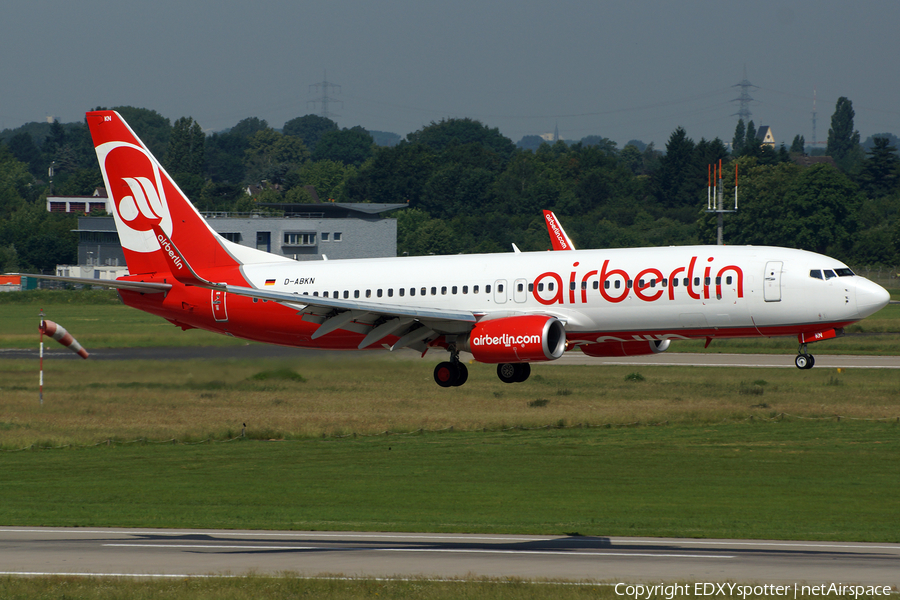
[0,98,900,271]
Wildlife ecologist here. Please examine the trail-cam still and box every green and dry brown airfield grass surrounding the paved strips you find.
[0,292,900,598]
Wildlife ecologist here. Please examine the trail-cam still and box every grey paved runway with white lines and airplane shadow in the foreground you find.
[0,527,900,592]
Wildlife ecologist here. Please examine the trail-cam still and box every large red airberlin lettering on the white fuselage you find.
[532,256,744,305]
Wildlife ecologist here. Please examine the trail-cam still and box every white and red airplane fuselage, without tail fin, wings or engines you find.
[123,246,883,349]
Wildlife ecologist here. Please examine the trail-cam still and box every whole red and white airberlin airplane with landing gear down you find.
[17,111,889,387]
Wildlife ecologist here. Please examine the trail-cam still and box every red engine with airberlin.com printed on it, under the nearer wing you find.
[460,315,566,363]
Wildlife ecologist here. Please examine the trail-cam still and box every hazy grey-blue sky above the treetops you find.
[0,0,900,147]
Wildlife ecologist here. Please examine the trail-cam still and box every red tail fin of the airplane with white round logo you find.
[87,110,289,275]
